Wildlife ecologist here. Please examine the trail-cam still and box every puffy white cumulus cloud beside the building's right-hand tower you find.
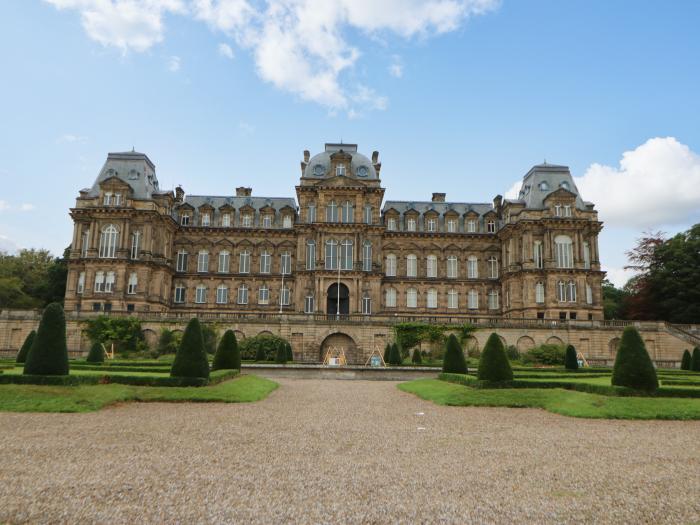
[575,137,700,228]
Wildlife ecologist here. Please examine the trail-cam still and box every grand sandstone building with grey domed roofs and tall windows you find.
[65,144,604,321]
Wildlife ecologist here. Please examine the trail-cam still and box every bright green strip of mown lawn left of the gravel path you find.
[0,375,278,412]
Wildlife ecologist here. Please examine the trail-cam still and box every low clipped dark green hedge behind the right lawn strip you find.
[438,374,700,399]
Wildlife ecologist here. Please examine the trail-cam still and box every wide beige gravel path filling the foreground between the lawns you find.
[0,379,700,524]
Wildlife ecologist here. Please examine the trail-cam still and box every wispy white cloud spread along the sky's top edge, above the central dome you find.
[45,0,500,113]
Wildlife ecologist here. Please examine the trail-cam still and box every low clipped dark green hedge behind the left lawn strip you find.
[0,370,240,387]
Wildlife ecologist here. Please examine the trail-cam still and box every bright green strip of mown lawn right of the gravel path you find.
[399,379,700,419]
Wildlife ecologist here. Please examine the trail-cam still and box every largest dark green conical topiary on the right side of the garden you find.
[612,326,659,392]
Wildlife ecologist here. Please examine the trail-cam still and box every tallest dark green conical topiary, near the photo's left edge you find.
[24,303,68,376]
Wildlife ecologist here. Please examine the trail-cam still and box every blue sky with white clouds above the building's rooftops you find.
[0,0,700,284]
